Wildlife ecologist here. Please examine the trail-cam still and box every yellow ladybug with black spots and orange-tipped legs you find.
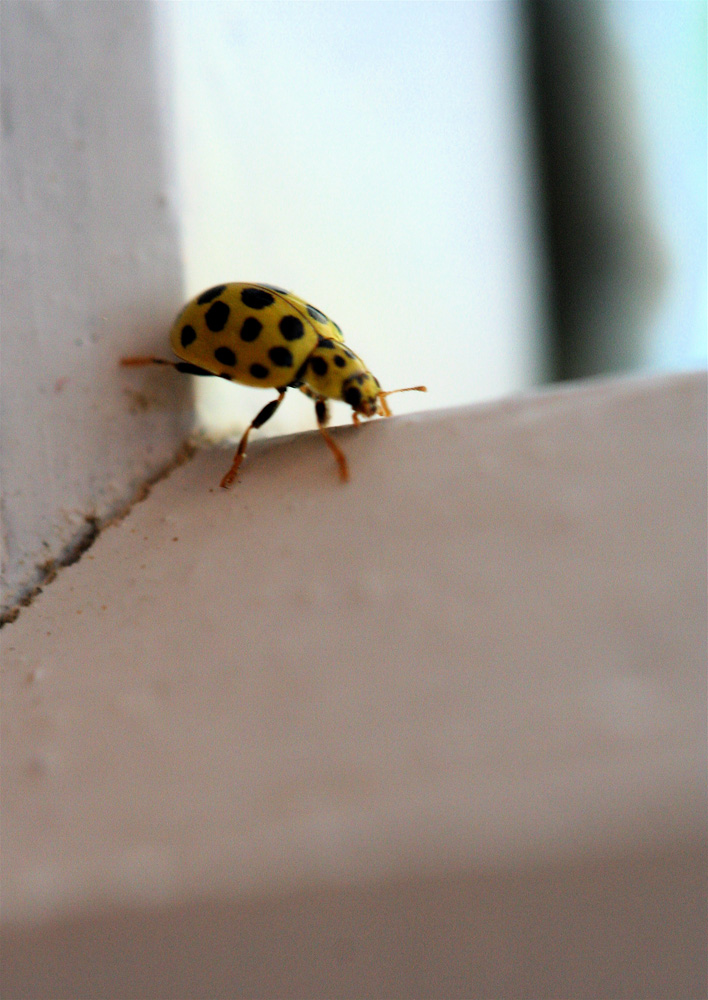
[121,282,426,489]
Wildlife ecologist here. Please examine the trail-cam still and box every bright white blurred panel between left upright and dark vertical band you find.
[157,2,544,433]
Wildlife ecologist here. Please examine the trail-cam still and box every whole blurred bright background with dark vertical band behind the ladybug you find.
[155,0,707,436]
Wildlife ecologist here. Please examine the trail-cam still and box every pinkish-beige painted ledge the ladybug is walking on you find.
[1,373,706,997]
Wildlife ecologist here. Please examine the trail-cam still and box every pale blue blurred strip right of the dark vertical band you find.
[604,0,708,370]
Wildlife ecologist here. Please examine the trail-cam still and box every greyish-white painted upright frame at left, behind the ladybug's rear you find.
[0,2,189,614]
